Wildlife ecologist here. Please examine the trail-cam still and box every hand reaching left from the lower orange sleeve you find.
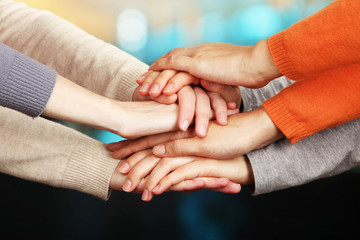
[107,107,283,159]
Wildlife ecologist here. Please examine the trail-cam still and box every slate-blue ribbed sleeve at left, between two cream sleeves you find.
[0,43,57,117]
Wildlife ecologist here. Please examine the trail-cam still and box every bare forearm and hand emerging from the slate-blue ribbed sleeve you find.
[43,75,178,138]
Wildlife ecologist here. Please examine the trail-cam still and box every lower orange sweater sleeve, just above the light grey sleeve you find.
[263,64,360,143]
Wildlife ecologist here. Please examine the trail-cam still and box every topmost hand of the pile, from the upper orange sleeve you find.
[150,40,282,88]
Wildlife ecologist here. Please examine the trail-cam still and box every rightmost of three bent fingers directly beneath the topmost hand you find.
[163,72,199,95]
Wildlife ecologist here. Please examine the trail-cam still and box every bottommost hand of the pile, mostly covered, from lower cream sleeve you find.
[110,151,240,197]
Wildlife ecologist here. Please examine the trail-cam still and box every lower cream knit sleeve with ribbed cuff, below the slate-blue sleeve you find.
[0,108,118,199]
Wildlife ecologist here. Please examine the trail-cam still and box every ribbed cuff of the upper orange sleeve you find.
[268,30,304,81]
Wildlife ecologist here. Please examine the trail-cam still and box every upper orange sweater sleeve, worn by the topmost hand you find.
[268,0,360,80]
